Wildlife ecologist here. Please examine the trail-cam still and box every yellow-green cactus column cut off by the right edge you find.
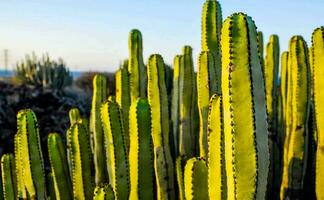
[311,27,324,199]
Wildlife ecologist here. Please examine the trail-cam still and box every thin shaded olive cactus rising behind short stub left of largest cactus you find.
[178,46,195,157]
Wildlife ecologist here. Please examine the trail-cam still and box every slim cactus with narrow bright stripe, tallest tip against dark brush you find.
[90,74,107,185]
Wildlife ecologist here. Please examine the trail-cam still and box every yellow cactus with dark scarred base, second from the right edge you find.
[280,36,310,199]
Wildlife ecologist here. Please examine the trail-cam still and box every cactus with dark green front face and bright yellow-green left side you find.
[129,99,155,199]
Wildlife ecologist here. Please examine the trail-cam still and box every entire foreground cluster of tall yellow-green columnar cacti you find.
[0,0,324,200]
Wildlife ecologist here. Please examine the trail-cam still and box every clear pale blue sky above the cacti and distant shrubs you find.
[0,0,324,71]
